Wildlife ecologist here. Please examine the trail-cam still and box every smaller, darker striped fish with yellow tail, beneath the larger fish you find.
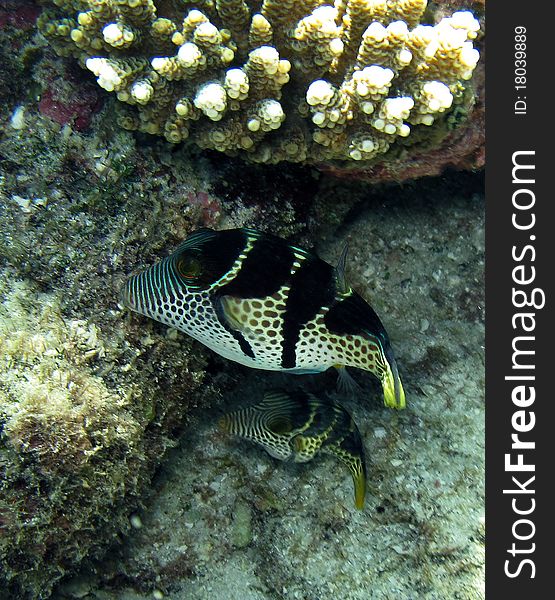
[219,390,366,509]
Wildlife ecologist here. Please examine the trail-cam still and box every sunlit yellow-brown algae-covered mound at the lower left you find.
[0,273,206,598]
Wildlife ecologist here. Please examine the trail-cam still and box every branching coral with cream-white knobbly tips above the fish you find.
[38,0,479,164]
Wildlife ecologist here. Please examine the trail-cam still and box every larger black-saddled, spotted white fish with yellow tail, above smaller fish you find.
[122,228,405,409]
